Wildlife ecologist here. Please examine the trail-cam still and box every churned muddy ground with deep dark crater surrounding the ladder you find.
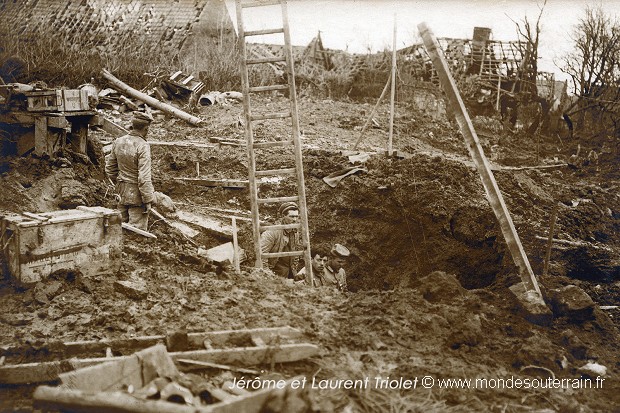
[0,96,620,412]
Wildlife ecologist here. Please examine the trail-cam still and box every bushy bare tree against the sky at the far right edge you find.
[561,6,620,133]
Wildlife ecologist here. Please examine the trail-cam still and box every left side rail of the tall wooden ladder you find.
[236,0,263,268]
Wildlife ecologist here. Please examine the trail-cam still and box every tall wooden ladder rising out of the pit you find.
[236,0,313,286]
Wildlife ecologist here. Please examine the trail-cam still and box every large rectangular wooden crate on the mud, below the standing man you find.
[0,207,123,286]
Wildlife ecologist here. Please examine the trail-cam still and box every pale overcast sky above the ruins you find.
[226,0,620,77]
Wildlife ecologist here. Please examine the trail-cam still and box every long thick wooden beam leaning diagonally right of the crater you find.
[418,23,542,299]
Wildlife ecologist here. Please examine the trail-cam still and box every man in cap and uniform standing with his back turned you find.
[105,112,155,230]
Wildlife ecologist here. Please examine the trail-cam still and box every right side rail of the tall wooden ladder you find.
[282,0,314,286]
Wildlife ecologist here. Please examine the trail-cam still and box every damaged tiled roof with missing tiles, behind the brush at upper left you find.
[0,0,234,52]
